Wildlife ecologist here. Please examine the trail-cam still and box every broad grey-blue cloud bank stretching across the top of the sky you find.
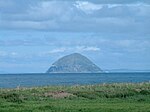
[0,0,150,35]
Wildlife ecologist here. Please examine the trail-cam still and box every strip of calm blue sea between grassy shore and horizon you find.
[0,72,150,88]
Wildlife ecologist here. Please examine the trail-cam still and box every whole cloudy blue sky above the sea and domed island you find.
[0,0,150,73]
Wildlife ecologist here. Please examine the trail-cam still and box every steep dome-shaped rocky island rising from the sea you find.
[47,53,102,73]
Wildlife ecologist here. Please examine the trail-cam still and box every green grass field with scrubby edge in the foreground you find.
[0,83,150,112]
